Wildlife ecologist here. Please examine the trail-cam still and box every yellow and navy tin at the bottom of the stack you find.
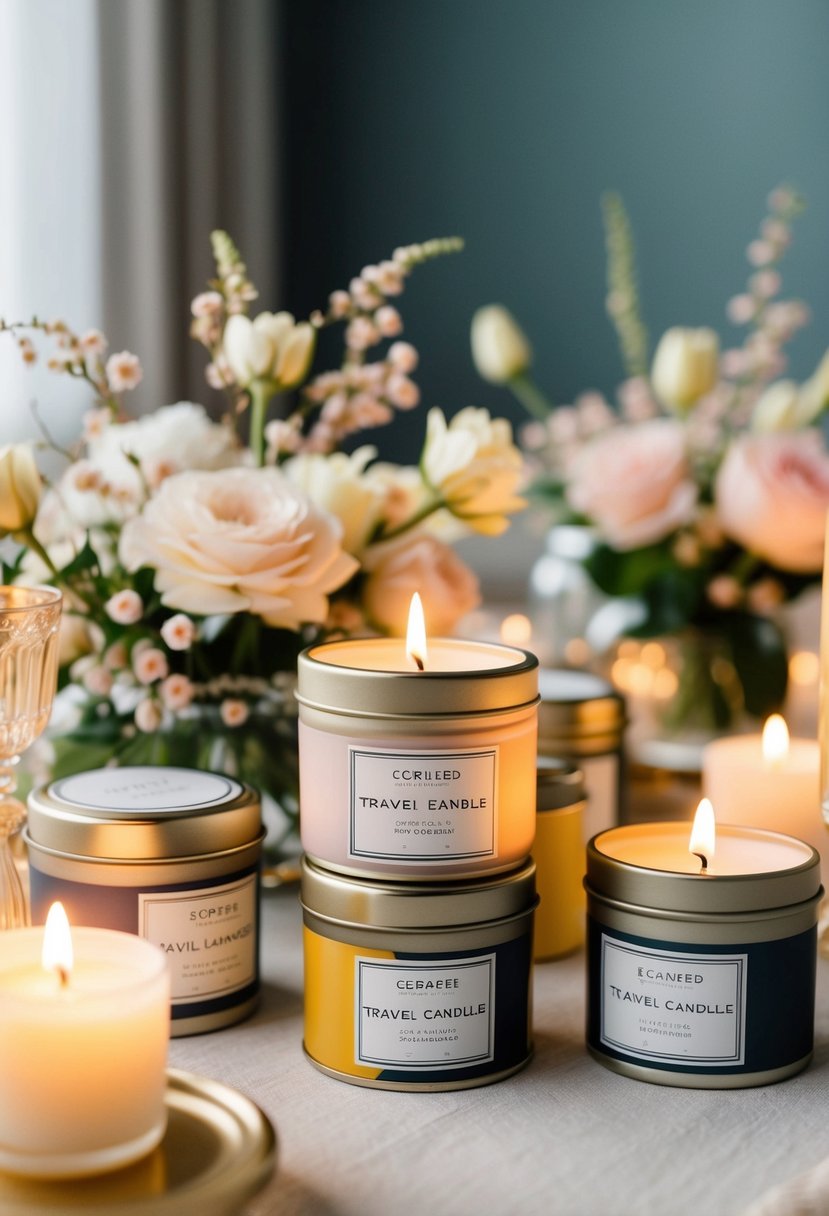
[301,860,537,1091]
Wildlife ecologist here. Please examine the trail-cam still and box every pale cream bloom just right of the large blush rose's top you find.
[281,446,384,554]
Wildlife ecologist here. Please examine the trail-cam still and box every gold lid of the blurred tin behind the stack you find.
[538,668,627,755]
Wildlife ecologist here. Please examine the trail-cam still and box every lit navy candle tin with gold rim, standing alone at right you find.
[586,823,823,1088]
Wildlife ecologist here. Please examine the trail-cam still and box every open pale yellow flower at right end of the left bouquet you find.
[421,406,526,536]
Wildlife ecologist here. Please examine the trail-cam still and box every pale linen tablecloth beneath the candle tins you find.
[170,888,829,1216]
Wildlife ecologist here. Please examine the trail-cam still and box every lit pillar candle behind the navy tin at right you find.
[703,714,829,886]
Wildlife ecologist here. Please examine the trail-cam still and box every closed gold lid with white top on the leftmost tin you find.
[27,765,261,861]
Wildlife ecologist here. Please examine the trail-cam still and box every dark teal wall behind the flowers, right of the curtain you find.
[283,0,829,456]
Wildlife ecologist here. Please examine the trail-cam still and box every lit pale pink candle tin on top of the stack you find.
[297,638,538,882]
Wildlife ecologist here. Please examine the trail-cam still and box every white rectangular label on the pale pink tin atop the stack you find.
[349,747,498,862]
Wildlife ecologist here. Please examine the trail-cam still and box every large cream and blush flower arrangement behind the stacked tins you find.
[0,232,524,851]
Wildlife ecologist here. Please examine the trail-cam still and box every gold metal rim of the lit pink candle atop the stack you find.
[297,638,538,717]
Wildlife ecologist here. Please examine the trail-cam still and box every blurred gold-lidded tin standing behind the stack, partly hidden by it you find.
[538,668,619,844]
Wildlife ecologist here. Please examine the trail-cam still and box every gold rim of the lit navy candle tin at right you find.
[586,822,822,916]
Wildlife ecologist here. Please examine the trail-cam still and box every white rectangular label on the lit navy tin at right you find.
[599,934,749,1068]
